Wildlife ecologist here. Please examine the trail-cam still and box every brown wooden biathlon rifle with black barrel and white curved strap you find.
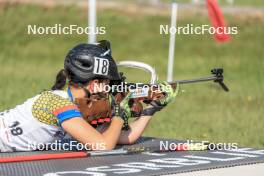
[76,61,229,129]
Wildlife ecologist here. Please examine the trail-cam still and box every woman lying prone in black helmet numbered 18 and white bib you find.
[0,42,178,152]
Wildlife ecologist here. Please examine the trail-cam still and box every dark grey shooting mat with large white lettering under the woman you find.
[0,137,264,176]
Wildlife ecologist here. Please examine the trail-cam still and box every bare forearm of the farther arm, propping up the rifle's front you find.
[118,116,152,144]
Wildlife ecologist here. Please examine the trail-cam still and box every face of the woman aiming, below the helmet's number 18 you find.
[86,79,110,94]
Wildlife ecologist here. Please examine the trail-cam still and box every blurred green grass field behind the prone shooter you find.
[0,5,264,148]
